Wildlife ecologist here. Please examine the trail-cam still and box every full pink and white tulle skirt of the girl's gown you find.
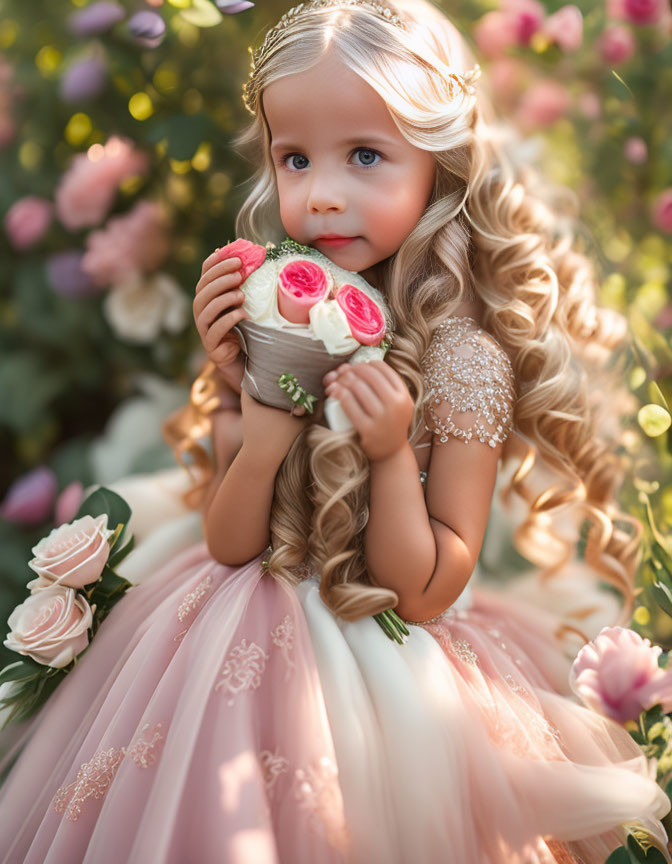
[0,318,672,864]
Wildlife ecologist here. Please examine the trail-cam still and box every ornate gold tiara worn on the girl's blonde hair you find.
[243,0,481,114]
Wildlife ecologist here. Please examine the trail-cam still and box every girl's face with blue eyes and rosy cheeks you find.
[262,53,435,272]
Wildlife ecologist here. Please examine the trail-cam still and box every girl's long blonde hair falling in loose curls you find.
[165,0,641,638]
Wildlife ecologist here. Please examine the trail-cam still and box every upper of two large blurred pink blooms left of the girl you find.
[55,137,149,231]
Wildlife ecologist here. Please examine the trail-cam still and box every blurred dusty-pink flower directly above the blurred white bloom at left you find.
[82,201,170,286]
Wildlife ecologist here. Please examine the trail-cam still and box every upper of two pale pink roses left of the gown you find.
[28,513,114,591]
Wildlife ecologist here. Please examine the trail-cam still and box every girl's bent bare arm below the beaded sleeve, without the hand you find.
[366,438,502,621]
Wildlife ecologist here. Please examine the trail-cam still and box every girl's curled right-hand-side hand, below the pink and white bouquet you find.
[323,360,414,462]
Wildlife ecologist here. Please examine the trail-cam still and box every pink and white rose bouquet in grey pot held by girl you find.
[220,238,391,428]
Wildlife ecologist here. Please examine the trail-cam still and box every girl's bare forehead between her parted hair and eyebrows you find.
[262,53,402,146]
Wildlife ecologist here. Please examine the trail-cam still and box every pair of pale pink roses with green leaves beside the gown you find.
[0,487,133,729]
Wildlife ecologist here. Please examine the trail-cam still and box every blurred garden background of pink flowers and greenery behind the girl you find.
[0,0,672,684]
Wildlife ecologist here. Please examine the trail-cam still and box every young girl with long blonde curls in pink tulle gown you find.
[0,0,671,864]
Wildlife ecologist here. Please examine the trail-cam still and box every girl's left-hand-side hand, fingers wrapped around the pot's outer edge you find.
[193,251,250,377]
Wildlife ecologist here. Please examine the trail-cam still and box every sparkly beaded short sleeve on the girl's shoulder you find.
[422,317,515,447]
